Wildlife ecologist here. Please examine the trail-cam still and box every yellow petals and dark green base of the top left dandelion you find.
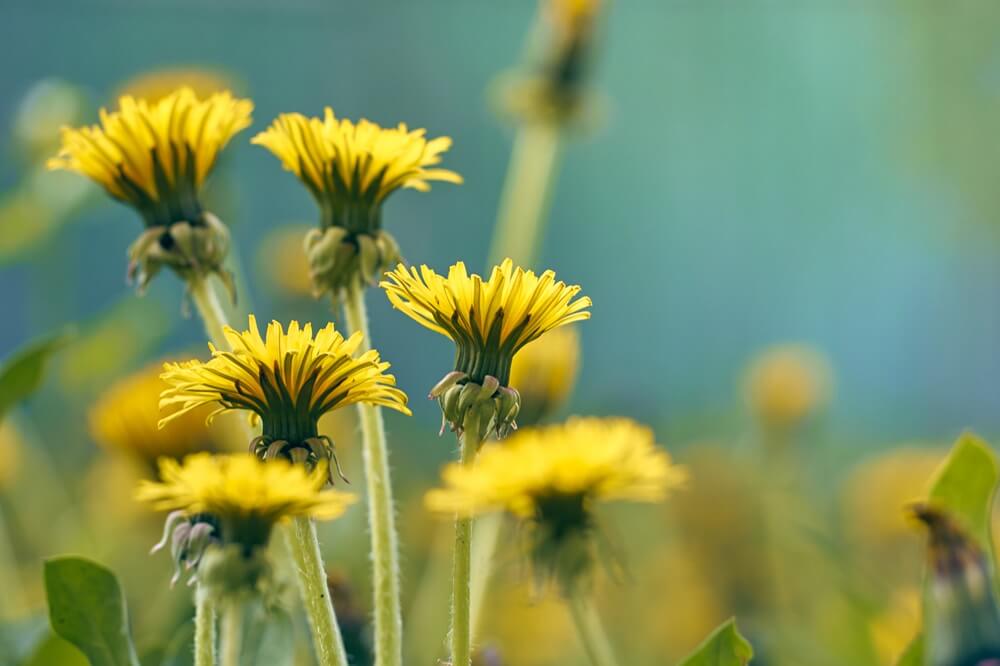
[49,88,253,226]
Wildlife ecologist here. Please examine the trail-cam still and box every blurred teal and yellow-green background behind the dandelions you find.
[0,0,1000,666]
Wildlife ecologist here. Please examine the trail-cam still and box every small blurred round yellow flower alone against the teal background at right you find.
[744,345,832,432]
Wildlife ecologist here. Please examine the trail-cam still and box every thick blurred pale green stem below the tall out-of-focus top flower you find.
[489,123,561,266]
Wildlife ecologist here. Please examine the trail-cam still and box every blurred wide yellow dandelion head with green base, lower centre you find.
[426,417,686,591]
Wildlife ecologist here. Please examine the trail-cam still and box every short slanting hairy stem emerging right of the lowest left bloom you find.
[287,516,347,666]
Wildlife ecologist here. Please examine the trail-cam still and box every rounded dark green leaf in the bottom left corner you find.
[45,557,139,666]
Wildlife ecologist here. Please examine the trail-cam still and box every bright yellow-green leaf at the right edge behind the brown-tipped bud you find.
[928,433,1000,553]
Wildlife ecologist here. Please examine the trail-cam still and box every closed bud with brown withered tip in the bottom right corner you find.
[913,504,1000,666]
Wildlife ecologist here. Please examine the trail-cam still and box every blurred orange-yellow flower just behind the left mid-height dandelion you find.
[90,364,221,466]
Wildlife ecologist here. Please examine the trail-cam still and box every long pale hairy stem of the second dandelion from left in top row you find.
[344,281,403,666]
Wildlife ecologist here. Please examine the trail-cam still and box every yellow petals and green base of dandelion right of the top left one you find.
[252,107,462,224]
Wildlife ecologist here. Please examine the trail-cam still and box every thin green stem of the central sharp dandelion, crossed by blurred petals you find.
[451,410,481,666]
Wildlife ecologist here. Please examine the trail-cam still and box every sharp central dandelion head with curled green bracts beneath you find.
[381,259,591,439]
